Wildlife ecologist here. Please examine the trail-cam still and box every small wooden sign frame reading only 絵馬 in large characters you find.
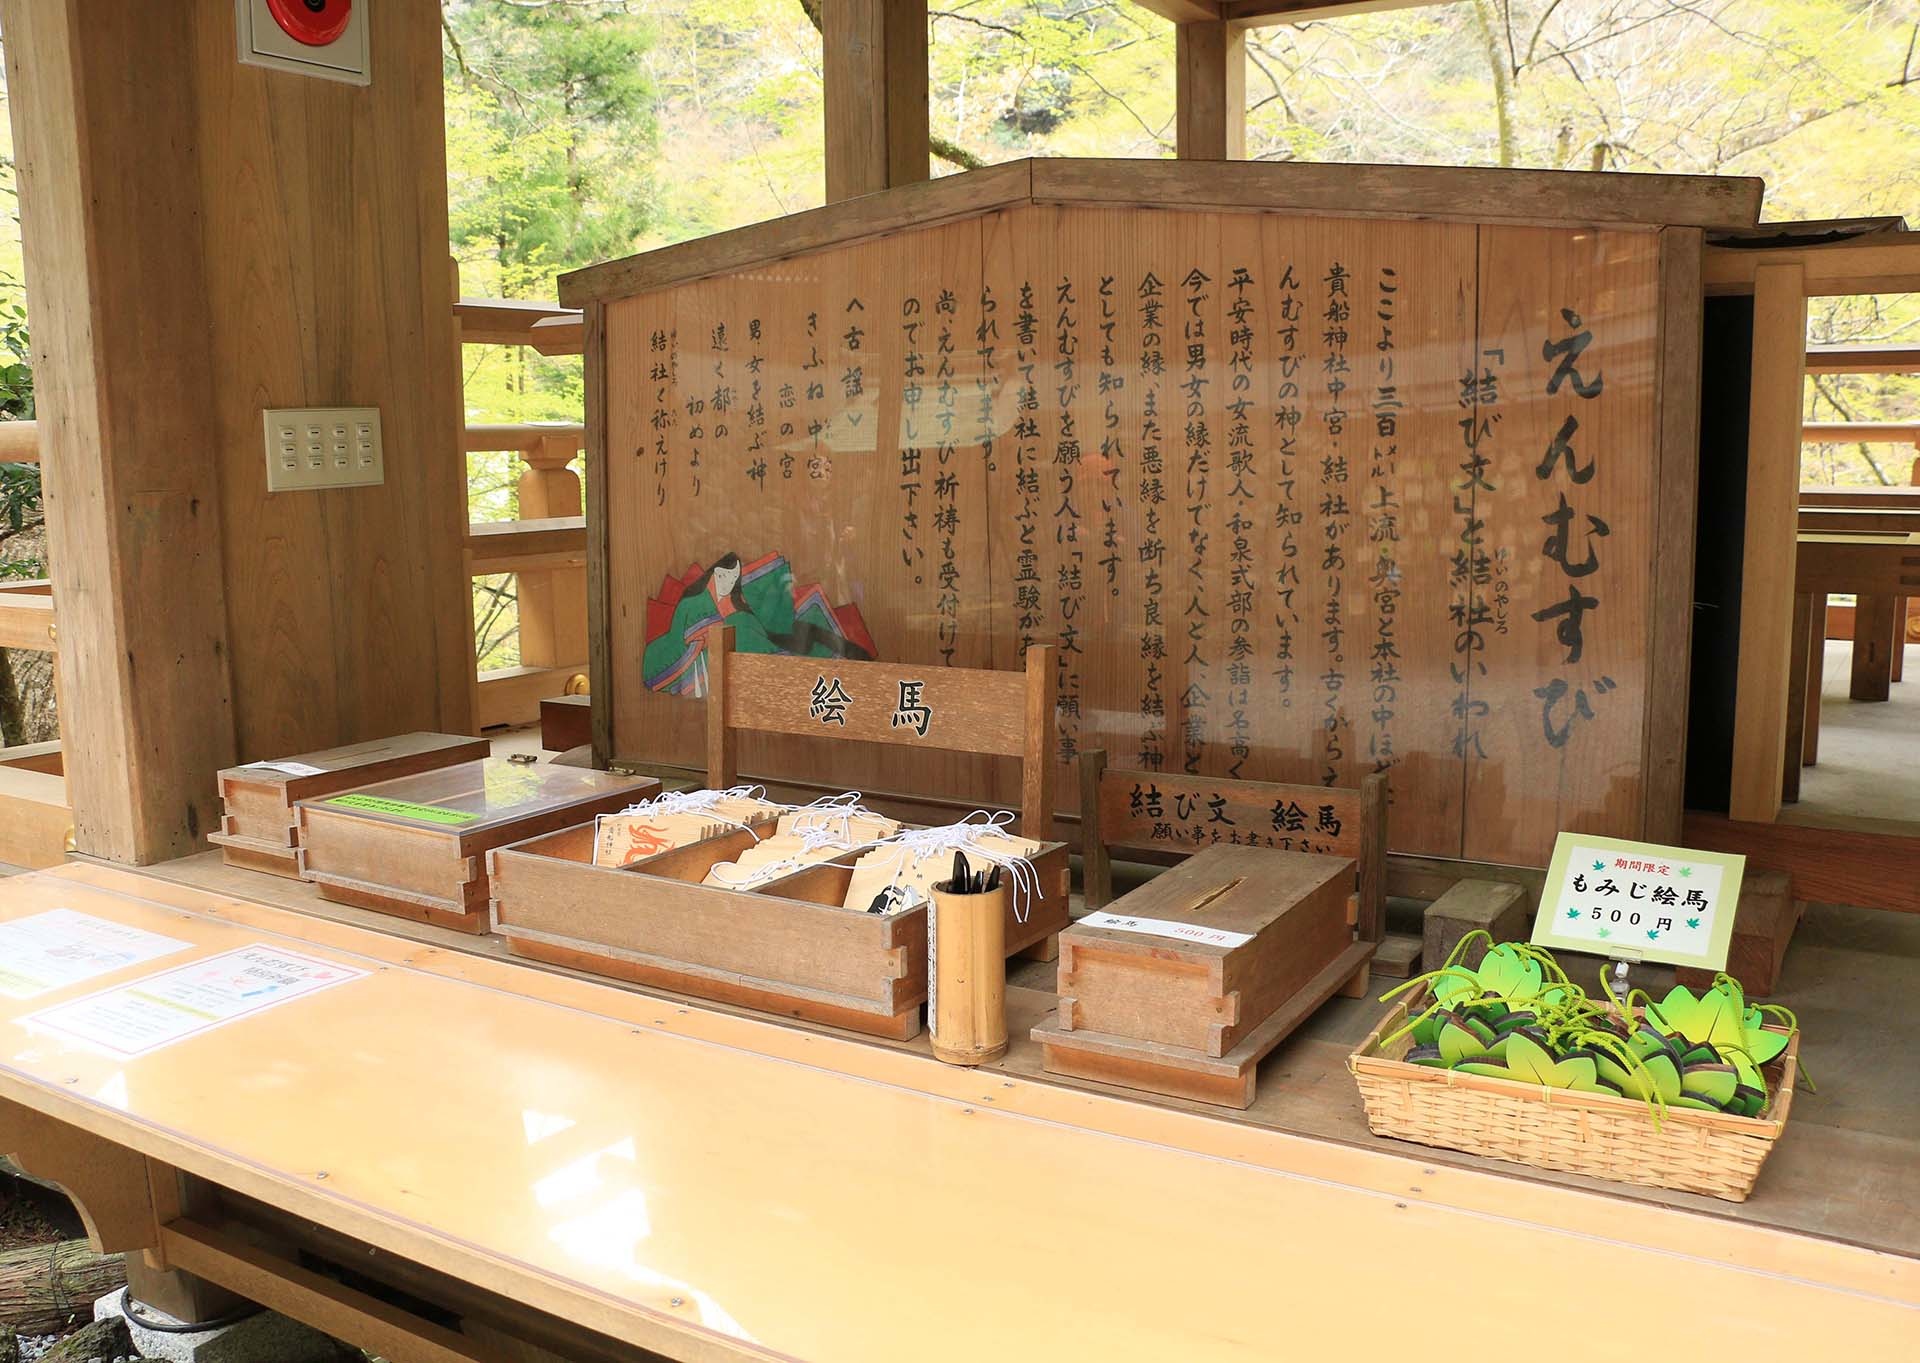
[707,628,1066,844]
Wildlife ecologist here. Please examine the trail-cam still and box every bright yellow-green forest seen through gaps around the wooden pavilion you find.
[0,0,1920,679]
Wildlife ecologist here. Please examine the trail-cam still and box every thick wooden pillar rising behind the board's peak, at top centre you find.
[820,0,931,203]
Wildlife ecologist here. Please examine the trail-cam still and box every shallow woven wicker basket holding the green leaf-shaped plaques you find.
[1346,994,1799,1202]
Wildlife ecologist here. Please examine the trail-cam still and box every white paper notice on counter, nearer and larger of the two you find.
[21,943,367,1058]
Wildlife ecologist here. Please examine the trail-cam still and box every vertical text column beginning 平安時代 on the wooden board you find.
[1227,265,1260,777]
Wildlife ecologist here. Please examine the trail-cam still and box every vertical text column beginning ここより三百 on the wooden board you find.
[1367,265,1405,772]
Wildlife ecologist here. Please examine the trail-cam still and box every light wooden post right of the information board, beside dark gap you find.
[1728,263,1807,824]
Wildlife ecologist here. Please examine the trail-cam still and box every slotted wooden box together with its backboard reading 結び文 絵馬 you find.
[1033,749,1386,1108]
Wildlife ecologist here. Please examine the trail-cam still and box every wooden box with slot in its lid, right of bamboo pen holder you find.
[1033,845,1371,1108]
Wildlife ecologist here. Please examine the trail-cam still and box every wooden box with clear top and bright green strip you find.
[298,758,660,933]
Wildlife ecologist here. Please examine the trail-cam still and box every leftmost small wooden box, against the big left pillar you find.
[207,733,490,879]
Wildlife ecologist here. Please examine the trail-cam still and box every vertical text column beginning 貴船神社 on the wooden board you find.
[1319,261,1354,785]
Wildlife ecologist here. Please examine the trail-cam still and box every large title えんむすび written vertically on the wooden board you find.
[1532,307,1613,749]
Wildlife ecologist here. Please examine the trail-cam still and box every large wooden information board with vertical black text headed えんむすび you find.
[568,163,1751,864]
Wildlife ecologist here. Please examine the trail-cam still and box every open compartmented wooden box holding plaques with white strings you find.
[488,825,1069,1040]
